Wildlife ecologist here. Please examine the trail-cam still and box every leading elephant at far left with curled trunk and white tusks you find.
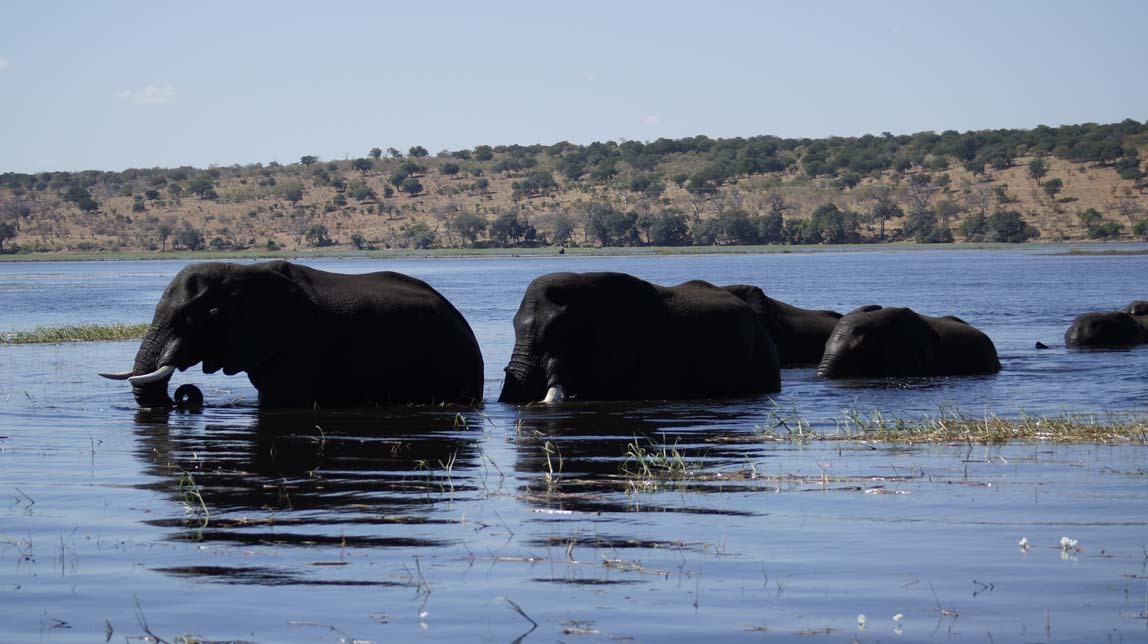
[92,261,483,408]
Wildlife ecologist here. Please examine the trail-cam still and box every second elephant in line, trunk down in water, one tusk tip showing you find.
[498,272,781,404]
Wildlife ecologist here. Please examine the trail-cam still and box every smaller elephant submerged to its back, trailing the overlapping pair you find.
[816,304,1001,378]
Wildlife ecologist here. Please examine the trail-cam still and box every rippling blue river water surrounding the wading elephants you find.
[0,249,1148,642]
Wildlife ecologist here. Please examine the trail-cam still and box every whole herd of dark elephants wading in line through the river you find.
[101,261,1148,408]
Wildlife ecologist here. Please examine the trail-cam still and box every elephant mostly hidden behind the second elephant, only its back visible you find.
[722,284,841,367]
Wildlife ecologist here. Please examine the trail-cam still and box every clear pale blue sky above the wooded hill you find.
[0,0,1148,172]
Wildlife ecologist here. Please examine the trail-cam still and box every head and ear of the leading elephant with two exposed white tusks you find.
[101,262,316,408]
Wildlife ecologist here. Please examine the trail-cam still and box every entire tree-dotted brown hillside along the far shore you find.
[0,119,1148,253]
